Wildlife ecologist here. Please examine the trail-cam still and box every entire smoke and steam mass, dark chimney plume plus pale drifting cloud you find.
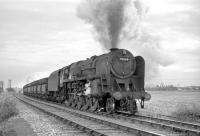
[77,0,173,81]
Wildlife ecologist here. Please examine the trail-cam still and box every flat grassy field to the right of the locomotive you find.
[139,90,200,122]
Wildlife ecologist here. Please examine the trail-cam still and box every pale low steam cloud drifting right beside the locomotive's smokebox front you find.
[126,31,174,81]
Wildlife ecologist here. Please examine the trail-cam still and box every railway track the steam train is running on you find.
[16,94,200,136]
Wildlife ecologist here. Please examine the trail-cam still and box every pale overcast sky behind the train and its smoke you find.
[0,0,200,87]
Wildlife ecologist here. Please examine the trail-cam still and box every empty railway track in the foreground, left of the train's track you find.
[16,96,163,136]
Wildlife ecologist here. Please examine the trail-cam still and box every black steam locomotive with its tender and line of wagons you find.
[23,48,151,114]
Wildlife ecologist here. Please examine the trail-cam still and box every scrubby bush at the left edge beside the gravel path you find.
[0,93,18,123]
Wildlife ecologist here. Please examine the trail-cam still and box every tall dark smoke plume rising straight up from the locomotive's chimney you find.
[77,0,142,49]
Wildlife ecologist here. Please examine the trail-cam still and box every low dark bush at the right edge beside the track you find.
[172,104,200,122]
